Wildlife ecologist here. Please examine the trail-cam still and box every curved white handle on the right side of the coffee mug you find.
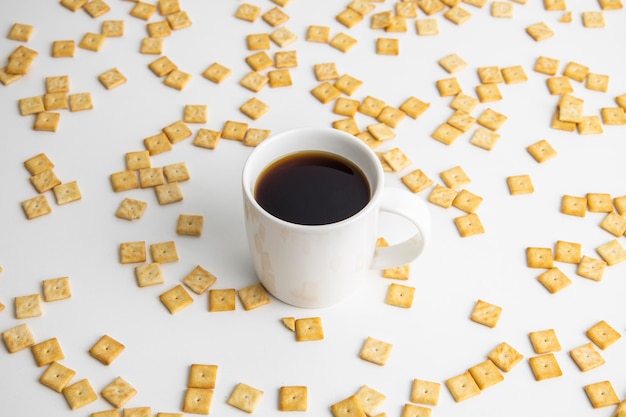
[370,187,430,269]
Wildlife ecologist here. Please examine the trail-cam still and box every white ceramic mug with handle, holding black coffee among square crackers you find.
[242,128,430,308]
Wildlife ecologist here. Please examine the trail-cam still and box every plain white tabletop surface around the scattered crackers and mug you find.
[0,0,626,417]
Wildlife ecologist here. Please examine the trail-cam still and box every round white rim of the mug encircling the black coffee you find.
[241,127,384,231]
